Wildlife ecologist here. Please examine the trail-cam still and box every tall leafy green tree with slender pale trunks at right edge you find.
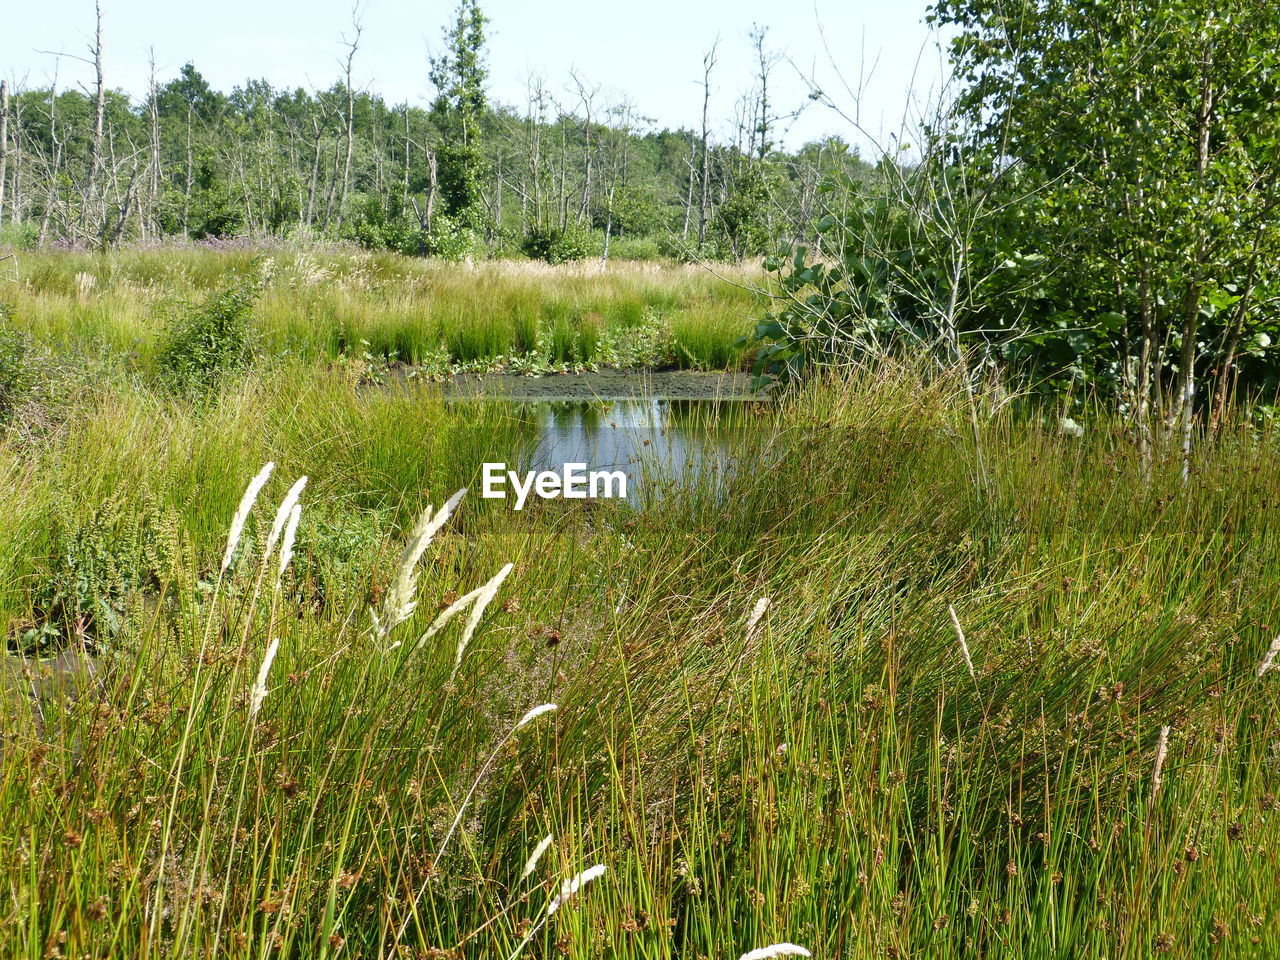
[936,0,1280,468]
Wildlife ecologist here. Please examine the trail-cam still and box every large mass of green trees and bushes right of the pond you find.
[758,0,1280,409]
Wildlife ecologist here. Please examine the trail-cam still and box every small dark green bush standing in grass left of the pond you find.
[156,271,262,394]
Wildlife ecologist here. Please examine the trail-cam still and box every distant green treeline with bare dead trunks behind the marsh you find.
[0,0,863,260]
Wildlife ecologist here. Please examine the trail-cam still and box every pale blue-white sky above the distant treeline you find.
[0,0,946,147]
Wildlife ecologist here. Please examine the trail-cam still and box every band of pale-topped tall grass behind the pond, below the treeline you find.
[0,247,758,369]
